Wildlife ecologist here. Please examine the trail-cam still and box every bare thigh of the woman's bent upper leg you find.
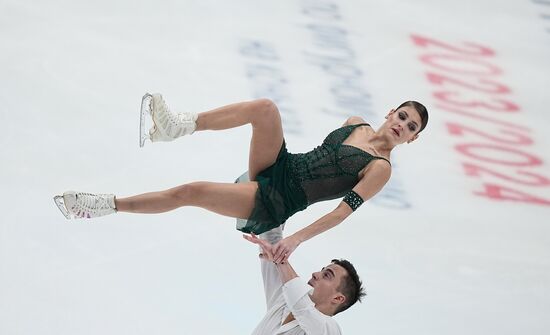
[248,100,283,180]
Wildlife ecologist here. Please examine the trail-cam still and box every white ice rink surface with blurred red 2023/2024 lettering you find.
[0,0,550,335]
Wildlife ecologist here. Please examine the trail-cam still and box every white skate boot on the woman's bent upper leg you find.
[139,93,198,147]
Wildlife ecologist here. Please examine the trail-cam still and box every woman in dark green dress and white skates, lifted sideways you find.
[54,94,428,263]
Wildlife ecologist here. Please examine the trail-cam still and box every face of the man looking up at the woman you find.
[307,264,347,304]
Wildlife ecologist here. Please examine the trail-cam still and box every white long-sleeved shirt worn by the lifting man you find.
[252,227,342,335]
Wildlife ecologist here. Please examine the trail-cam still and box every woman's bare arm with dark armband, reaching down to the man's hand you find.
[273,160,391,263]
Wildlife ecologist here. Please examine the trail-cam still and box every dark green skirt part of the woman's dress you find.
[235,141,307,234]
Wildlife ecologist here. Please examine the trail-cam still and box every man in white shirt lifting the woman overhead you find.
[244,226,365,335]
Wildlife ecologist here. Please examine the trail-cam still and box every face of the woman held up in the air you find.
[381,106,422,145]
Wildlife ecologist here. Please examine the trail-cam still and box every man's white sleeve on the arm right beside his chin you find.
[283,277,342,335]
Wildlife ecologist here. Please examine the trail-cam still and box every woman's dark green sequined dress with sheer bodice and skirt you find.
[236,123,389,234]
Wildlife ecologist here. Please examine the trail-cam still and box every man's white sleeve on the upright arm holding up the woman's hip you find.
[260,226,283,309]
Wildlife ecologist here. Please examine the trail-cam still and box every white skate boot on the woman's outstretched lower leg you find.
[53,191,116,219]
